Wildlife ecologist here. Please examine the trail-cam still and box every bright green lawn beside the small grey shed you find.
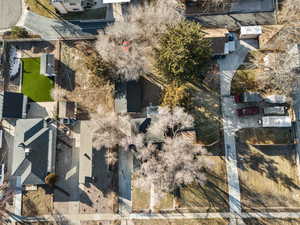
[22,58,54,102]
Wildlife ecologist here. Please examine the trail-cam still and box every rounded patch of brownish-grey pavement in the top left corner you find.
[0,0,22,30]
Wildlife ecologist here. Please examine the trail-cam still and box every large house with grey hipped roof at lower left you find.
[11,119,55,185]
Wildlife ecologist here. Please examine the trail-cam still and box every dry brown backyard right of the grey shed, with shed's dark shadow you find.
[57,42,114,119]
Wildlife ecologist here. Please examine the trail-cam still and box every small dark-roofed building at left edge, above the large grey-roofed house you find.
[0,91,28,119]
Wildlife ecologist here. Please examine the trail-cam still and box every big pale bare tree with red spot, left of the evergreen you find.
[96,0,182,80]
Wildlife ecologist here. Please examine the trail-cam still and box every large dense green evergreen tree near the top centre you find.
[155,21,211,82]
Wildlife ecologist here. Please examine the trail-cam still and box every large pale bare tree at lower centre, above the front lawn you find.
[139,136,207,192]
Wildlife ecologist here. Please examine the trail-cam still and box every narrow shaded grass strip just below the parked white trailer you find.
[237,127,293,145]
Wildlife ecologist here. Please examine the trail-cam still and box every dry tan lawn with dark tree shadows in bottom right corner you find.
[237,143,300,211]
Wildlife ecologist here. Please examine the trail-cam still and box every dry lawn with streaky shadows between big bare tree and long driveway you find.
[178,156,229,212]
